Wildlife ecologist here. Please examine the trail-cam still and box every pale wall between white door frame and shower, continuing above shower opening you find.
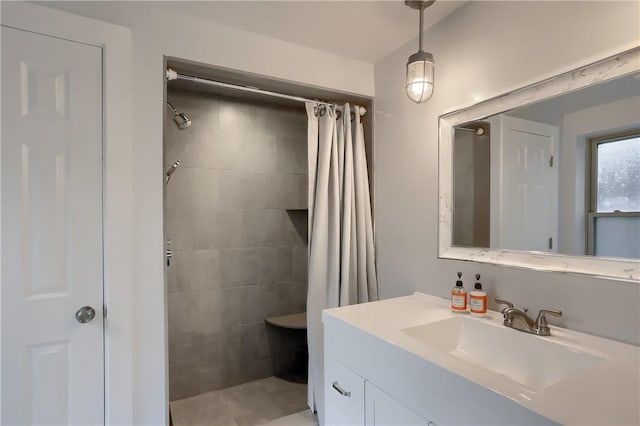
[38,2,374,425]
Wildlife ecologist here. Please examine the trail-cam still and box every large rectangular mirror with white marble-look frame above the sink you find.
[439,48,640,281]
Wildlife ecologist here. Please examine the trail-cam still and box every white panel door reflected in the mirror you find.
[499,116,559,251]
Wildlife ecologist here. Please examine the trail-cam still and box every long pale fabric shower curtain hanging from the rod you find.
[306,102,378,425]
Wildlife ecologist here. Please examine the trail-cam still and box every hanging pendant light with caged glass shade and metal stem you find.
[404,0,435,104]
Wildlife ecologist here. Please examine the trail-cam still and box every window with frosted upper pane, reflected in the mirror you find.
[587,129,640,259]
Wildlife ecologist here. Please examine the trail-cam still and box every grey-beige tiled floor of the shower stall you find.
[170,377,317,426]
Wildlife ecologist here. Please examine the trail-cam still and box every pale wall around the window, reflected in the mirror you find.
[558,96,640,254]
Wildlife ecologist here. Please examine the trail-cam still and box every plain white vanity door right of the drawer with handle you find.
[365,382,436,426]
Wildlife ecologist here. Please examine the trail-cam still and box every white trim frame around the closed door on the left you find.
[0,2,134,424]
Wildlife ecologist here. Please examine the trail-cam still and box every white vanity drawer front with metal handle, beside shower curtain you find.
[324,357,364,426]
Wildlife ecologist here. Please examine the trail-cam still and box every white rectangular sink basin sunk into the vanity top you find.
[402,316,606,391]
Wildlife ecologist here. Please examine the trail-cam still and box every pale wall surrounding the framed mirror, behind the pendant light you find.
[375,1,640,344]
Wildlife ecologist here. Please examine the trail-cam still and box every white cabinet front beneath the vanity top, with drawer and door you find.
[324,357,435,426]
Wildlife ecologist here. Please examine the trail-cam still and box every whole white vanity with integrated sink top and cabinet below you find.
[322,293,640,426]
